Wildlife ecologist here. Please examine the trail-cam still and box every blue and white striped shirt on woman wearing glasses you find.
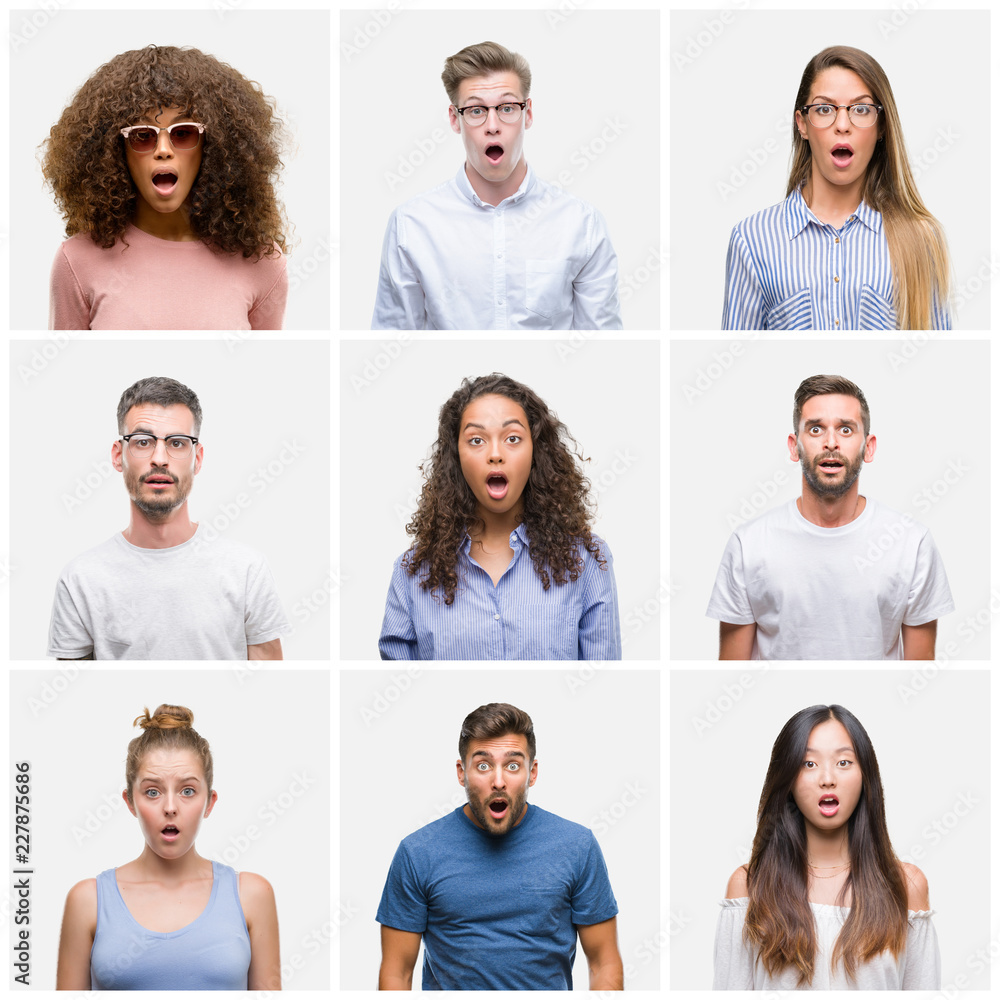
[722,191,951,330]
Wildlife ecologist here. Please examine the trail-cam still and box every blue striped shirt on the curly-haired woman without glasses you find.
[378,524,622,660]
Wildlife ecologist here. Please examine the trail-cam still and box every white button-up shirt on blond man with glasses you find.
[372,164,622,330]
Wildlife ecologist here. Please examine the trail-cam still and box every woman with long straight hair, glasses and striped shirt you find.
[722,45,951,330]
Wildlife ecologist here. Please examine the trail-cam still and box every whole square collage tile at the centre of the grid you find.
[340,337,662,660]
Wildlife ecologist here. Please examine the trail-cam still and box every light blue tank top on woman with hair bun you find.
[90,861,250,990]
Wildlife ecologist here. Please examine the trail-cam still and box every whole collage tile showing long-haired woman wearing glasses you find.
[669,5,996,330]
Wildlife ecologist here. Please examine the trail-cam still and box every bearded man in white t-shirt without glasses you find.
[707,375,955,660]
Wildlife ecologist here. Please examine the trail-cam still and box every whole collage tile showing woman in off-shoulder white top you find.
[669,667,993,993]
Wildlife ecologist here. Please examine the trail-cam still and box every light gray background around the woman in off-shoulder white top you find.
[670,669,991,993]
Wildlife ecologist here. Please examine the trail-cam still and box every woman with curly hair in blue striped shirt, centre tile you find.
[379,373,621,660]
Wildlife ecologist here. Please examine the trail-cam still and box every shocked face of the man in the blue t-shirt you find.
[456,733,538,837]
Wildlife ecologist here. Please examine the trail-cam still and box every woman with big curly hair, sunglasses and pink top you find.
[42,45,288,330]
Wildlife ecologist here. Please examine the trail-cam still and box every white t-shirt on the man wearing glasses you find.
[48,527,291,660]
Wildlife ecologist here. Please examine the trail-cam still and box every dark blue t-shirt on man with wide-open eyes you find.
[376,805,618,990]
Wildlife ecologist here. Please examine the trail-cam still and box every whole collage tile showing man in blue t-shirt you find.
[340,664,664,990]
